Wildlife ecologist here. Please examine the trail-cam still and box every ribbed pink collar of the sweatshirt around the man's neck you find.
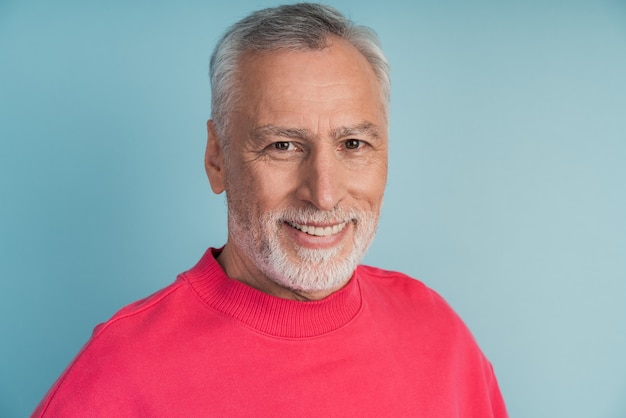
[182,248,361,338]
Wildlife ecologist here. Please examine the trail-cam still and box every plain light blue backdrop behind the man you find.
[0,0,626,418]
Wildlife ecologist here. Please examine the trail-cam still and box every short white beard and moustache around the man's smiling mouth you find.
[225,154,379,291]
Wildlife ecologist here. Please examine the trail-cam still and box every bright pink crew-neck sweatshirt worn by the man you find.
[33,249,507,418]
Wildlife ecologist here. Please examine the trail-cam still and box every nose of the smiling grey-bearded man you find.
[296,149,347,210]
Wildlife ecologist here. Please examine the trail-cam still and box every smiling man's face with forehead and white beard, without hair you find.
[207,35,387,296]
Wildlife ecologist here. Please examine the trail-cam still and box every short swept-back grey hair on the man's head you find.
[210,3,391,147]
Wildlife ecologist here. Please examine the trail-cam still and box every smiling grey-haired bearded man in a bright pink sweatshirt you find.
[35,4,506,418]
